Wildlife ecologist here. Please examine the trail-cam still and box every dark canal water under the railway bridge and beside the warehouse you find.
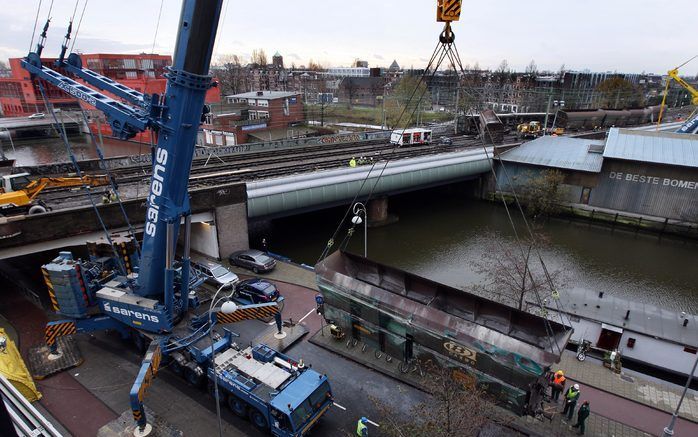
[266,184,698,314]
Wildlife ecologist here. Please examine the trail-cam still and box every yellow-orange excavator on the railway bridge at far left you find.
[0,173,110,214]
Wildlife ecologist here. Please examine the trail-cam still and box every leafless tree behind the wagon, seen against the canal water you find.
[472,228,566,310]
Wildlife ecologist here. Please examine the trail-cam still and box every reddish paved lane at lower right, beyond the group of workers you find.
[561,376,698,436]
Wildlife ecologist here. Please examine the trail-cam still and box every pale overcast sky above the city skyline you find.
[0,0,698,75]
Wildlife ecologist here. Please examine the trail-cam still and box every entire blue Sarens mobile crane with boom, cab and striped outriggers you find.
[22,0,332,437]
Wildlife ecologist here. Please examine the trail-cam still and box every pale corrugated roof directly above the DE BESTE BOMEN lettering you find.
[603,128,698,167]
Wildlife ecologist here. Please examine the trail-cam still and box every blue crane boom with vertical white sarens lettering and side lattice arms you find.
[22,0,222,310]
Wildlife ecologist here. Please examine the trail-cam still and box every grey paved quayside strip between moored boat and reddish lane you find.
[559,353,698,423]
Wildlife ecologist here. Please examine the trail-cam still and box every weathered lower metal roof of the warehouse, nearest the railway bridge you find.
[499,136,603,173]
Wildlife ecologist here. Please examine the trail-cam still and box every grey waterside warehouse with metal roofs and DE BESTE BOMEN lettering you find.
[497,128,698,222]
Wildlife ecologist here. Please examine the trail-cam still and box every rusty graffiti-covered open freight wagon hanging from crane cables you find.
[315,251,572,415]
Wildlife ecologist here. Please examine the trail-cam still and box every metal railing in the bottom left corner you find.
[0,375,63,437]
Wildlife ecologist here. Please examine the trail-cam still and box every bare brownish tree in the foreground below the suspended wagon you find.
[371,361,500,437]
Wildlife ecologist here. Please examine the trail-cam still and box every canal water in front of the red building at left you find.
[0,135,145,166]
